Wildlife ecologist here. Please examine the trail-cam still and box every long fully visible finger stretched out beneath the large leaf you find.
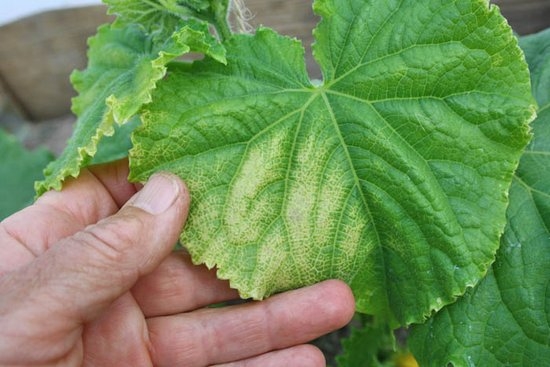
[148,280,355,366]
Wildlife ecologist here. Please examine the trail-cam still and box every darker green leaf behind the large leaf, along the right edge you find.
[410,30,550,367]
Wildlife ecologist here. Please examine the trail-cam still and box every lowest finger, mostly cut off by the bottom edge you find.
[211,344,326,367]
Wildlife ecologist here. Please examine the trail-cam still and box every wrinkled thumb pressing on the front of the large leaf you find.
[6,173,189,323]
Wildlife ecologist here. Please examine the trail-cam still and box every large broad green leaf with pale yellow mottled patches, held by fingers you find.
[130,0,534,326]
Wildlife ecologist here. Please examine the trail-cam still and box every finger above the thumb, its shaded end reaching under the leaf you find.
[0,160,136,274]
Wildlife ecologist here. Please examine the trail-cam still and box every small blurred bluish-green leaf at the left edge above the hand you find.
[0,129,53,220]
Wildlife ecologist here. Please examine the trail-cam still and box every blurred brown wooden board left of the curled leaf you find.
[0,6,110,120]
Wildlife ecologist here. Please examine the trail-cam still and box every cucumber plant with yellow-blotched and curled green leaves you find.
[16,0,550,366]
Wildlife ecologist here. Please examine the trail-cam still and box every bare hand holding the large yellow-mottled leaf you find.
[0,161,354,367]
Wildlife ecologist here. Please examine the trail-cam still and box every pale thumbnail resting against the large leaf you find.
[132,173,180,215]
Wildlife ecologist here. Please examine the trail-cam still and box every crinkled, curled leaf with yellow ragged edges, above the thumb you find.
[35,21,225,195]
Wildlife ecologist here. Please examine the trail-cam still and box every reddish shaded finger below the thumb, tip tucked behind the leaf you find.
[132,251,239,317]
